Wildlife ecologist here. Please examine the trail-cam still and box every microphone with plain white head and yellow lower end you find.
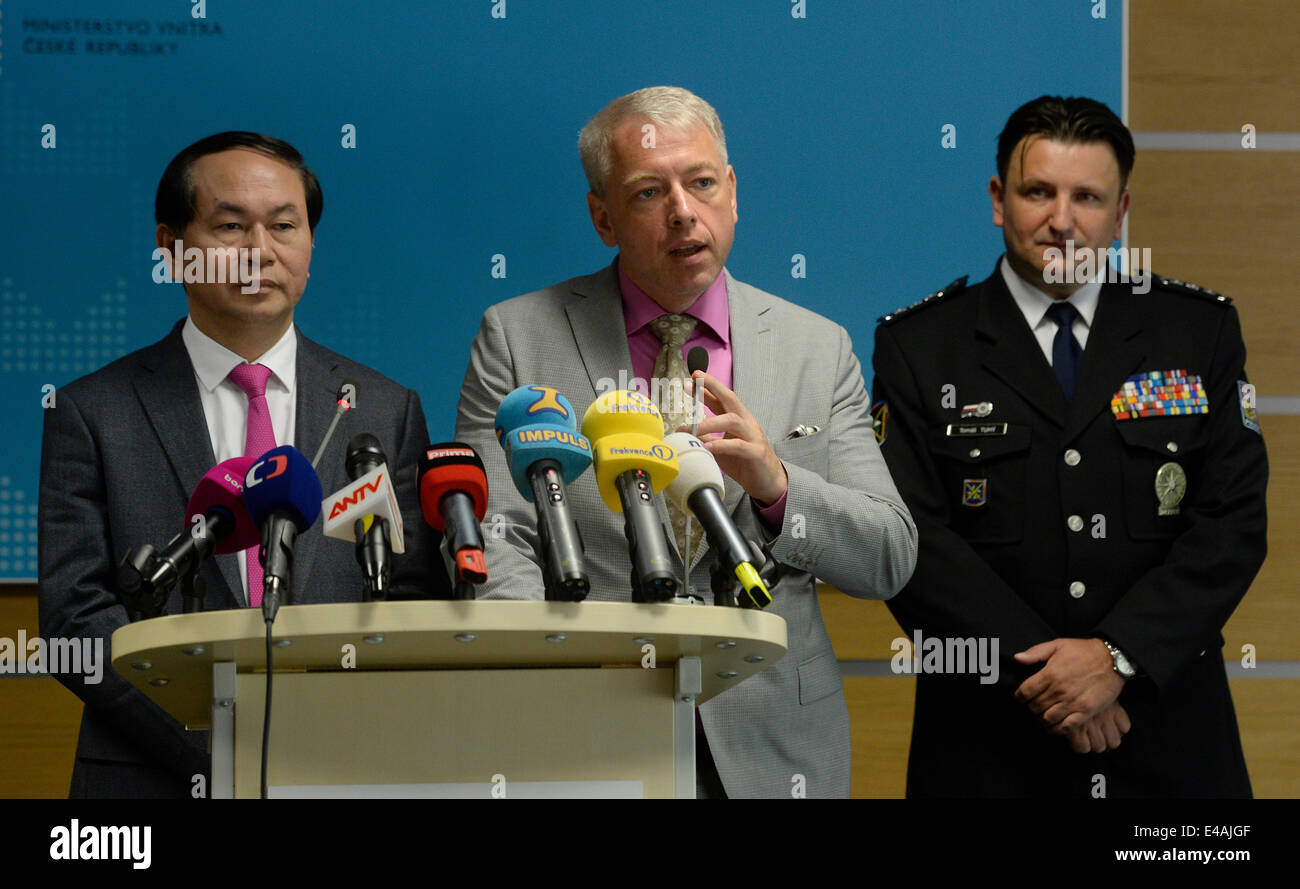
[663,433,772,608]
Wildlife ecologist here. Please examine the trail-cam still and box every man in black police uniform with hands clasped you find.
[875,96,1268,797]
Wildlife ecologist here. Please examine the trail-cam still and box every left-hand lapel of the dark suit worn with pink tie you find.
[135,321,243,608]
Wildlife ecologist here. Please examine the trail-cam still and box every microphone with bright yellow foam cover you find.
[582,390,677,602]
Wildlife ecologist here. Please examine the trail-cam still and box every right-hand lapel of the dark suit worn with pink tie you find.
[293,331,340,602]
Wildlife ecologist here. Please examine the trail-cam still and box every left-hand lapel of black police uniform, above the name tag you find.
[975,275,1066,426]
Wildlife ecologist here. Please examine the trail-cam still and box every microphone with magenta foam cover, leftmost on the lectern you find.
[118,456,259,615]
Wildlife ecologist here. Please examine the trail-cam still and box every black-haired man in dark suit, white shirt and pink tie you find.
[40,133,449,797]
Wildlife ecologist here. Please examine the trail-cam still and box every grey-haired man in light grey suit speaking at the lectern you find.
[456,87,917,798]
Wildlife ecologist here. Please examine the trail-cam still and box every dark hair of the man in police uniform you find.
[997,96,1136,191]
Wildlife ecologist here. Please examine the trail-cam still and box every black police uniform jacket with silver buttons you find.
[875,268,1268,797]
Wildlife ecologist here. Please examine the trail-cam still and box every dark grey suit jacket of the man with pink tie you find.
[39,321,450,797]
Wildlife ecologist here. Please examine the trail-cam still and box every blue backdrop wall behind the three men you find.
[0,0,1123,578]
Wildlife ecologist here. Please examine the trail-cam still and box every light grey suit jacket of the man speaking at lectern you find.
[456,265,917,798]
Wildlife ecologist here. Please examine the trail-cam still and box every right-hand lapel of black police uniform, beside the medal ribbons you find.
[1065,285,1145,441]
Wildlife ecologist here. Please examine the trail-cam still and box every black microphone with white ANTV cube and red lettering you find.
[321,433,406,602]
